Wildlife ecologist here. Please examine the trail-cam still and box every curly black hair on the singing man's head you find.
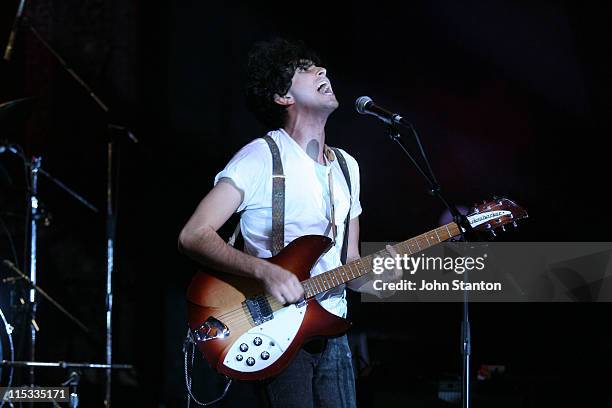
[245,38,320,129]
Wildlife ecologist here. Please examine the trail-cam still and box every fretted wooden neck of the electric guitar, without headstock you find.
[302,222,461,299]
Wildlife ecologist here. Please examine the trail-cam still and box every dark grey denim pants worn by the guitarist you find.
[262,335,356,408]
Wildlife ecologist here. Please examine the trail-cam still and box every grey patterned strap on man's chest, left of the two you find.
[263,135,285,256]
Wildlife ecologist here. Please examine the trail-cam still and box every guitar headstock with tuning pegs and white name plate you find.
[467,198,528,235]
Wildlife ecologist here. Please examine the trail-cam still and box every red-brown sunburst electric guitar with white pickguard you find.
[187,198,527,380]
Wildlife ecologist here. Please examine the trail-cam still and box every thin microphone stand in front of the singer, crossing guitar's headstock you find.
[387,121,475,408]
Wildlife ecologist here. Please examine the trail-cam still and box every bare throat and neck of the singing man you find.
[283,111,327,164]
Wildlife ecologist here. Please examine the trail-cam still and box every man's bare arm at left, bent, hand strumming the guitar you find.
[179,178,304,304]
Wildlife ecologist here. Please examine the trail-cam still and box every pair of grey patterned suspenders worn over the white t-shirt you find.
[228,135,353,264]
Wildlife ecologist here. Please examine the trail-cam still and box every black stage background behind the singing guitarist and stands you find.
[0,0,612,407]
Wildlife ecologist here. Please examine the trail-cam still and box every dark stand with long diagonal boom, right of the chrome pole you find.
[10,15,139,408]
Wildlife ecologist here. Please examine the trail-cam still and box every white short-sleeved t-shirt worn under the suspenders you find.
[215,129,361,317]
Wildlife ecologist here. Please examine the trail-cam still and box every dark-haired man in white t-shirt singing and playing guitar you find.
[179,39,394,408]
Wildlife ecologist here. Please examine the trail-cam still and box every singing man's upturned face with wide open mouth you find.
[287,61,338,113]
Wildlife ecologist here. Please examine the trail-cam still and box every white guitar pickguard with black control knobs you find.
[223,303,308,373]
